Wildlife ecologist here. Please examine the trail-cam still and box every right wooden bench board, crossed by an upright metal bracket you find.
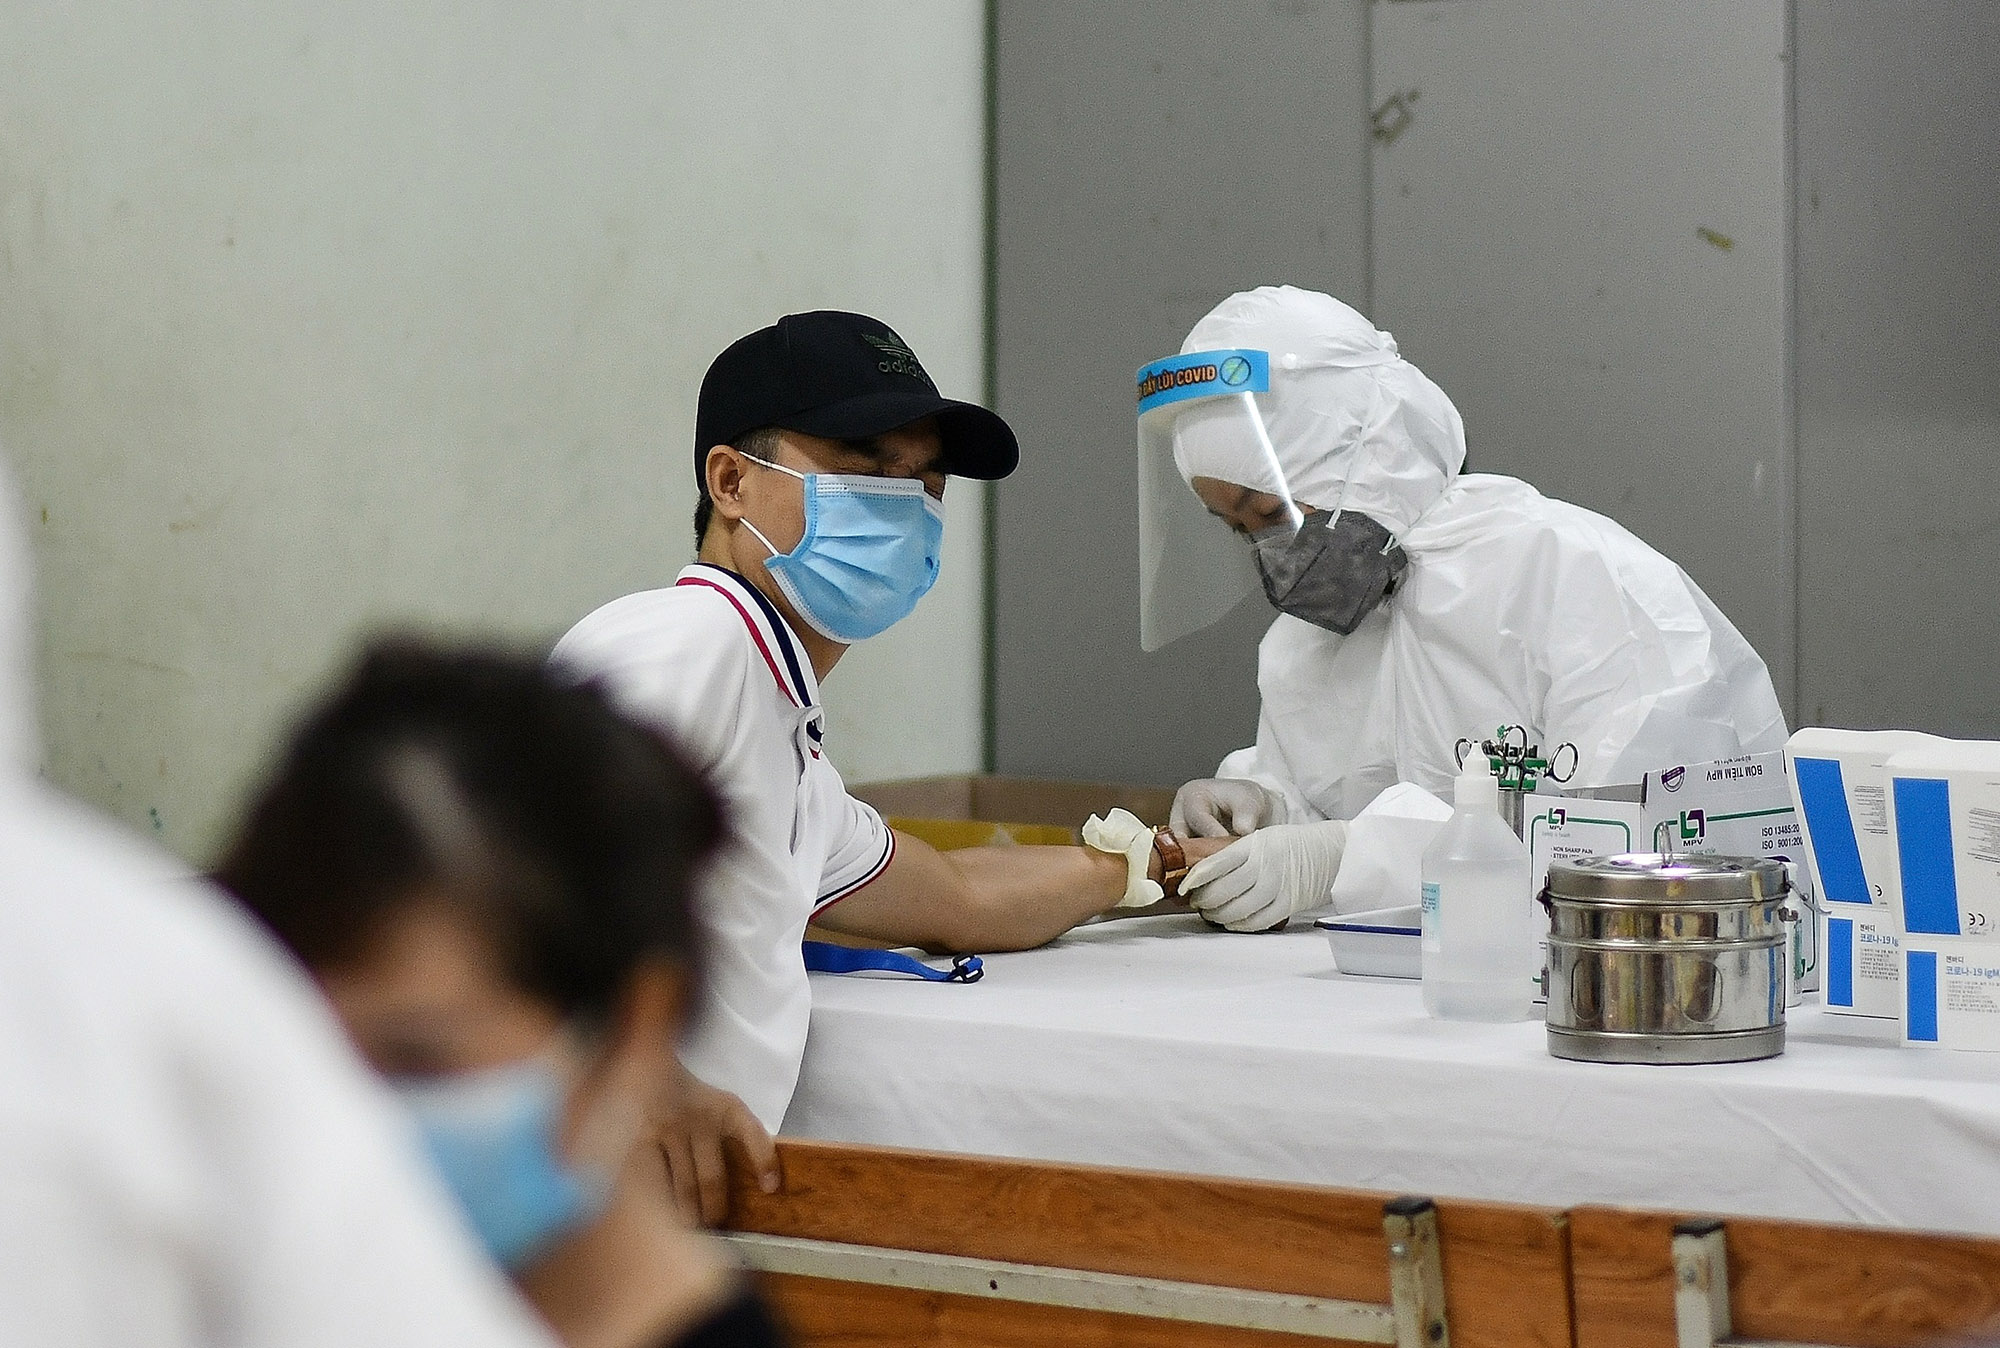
[1570,1208,2000,1348]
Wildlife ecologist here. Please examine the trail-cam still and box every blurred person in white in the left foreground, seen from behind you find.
[0,464,548,1348]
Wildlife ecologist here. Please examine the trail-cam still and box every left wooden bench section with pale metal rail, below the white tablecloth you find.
[728,1140,1574,1348]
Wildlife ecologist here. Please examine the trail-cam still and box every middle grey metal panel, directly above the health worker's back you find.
[1372,0,1794,710]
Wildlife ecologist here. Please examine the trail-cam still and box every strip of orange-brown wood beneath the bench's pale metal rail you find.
[760,1274,1384,1348]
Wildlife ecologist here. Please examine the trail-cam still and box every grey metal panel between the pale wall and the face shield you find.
[994,0,1368,782]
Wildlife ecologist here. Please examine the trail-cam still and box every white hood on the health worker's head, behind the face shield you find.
[1174,286,1466,538]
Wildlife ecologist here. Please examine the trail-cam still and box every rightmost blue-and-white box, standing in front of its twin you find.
[1882,740,2000,1052]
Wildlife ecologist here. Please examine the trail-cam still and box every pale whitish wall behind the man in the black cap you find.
[0,0,984,858]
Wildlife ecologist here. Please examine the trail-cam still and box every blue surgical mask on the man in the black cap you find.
[744,460,944,644]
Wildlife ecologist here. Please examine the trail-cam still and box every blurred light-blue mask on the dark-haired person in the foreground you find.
[396,1058,612,1270]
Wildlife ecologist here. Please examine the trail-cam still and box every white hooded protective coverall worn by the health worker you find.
[1174,286,1786,840]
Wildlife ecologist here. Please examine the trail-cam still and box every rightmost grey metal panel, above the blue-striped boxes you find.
[1796,0,2000,738]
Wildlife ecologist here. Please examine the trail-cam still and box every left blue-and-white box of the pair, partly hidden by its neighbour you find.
[1784,728,1944,1012]
